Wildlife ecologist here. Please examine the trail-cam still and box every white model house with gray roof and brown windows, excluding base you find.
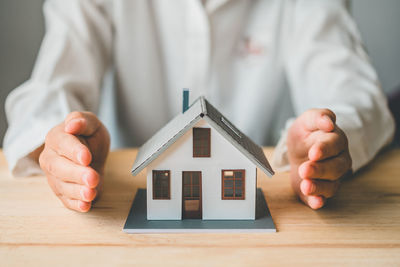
[132,97,274,220]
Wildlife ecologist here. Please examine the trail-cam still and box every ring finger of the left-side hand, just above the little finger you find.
[54,178,97,202]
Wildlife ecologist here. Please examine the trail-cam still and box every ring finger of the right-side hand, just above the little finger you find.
[300,179,340,198]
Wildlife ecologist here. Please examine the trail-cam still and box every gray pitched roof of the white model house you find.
[132,97,274,177]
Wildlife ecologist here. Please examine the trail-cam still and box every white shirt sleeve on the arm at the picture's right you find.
[273,0,394,171]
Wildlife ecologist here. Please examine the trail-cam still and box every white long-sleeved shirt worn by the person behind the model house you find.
[4,0,394,176]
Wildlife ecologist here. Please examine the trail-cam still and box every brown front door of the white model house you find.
[182,172,202,219]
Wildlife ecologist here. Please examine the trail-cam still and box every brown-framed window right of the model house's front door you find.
[222,170,245,199]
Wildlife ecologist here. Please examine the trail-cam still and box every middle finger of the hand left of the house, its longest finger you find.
[39,149,100,188]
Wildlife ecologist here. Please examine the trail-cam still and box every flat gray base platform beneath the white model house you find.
[123,188,276,234]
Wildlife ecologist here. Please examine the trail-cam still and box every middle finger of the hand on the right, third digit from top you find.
[298,152,352,181]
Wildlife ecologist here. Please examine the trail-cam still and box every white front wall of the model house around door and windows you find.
[147,119,257,220]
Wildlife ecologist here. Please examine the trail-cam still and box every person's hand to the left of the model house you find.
[39,112,110,212]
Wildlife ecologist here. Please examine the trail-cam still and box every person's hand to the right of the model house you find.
[287,109,352,209]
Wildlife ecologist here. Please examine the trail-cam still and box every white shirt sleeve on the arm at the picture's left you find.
[3,0,112,176]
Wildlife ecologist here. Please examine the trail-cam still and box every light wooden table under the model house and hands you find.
[0,149,400,266]
